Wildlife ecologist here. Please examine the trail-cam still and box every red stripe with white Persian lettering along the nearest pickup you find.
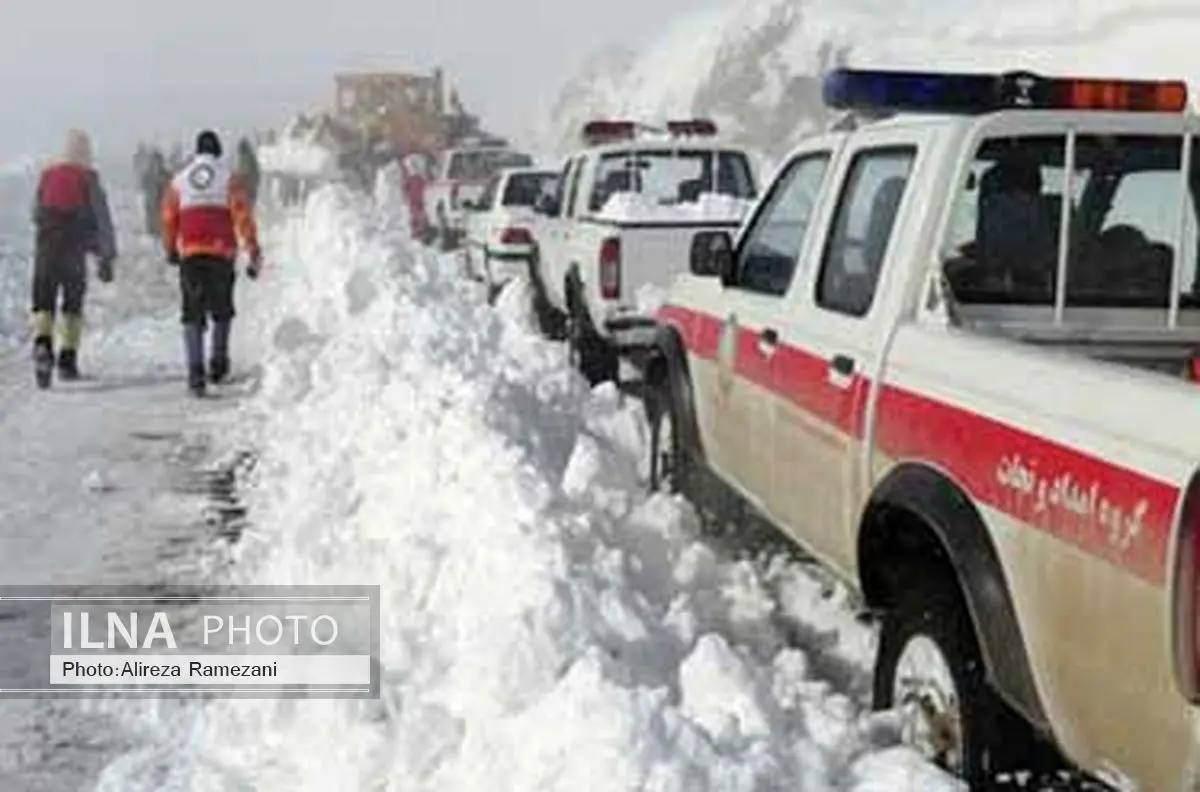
[659,306,1180,586]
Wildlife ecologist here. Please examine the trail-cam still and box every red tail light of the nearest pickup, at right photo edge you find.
[1171,470,1200,703]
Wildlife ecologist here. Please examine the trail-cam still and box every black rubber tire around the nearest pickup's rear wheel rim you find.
[874,570,1033,790]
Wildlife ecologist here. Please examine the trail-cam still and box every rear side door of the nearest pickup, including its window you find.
[768,130,919,570]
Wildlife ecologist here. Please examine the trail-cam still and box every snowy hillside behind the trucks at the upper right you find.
[538,0,1200,157]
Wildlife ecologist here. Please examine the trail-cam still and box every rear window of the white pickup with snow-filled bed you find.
[588,149,755,211]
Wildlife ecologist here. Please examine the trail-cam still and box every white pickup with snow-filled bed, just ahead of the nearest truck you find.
[532,119,757,382]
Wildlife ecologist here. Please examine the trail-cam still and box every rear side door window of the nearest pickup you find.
[817,146,917,317]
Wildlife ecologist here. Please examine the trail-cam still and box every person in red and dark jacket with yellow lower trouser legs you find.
[32,130,116,388]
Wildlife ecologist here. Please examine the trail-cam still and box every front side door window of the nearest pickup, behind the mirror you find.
[737,151,829,296]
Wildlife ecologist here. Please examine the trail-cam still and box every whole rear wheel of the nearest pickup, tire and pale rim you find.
[874,572,1027,790]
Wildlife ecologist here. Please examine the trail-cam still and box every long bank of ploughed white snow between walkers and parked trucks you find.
[98,180,950,792]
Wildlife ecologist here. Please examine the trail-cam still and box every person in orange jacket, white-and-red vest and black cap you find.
[162,130,263,396]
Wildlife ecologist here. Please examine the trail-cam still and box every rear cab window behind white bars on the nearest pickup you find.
[946,134,1200,308]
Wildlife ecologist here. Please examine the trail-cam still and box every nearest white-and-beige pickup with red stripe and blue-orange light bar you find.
[646,70,1200,790]
